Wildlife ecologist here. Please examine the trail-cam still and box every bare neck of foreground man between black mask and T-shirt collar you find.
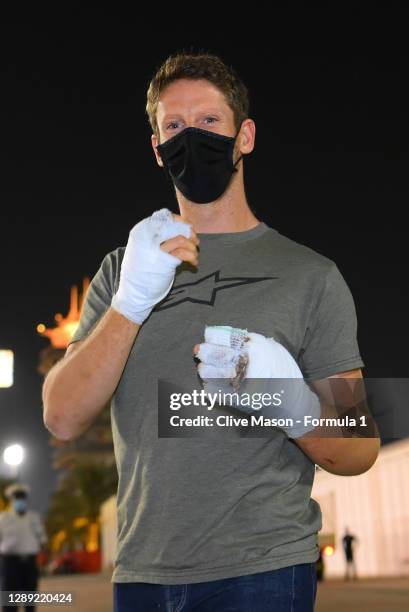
[176,172,260,234]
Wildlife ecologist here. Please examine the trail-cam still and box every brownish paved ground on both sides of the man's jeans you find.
[38,574,409,612]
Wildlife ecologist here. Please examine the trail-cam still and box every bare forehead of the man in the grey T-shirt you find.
[157,79,233,122]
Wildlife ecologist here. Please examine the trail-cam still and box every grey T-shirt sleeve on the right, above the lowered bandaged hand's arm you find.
[299,263,365,380]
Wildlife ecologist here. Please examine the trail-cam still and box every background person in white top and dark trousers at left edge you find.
[0,483,47,610]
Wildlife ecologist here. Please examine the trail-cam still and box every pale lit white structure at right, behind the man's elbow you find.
[311,439,409,578]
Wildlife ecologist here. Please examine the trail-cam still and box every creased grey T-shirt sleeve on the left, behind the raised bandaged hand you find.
[69,249,118,344]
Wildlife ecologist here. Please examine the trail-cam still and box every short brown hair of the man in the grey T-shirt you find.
[146,51,249,137]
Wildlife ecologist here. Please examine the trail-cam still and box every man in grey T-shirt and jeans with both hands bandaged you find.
[43,53,379,612]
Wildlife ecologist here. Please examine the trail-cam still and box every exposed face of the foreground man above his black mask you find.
[152,79,244,166]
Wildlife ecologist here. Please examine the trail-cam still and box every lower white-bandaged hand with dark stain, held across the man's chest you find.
[195,325,321,438]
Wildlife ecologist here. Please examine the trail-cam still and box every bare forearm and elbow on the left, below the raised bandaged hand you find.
[43,308,140,440]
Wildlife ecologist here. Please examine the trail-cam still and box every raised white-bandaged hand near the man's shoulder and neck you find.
[111,208,191,324]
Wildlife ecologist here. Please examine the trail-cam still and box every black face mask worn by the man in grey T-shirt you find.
[156,127,243,204]
